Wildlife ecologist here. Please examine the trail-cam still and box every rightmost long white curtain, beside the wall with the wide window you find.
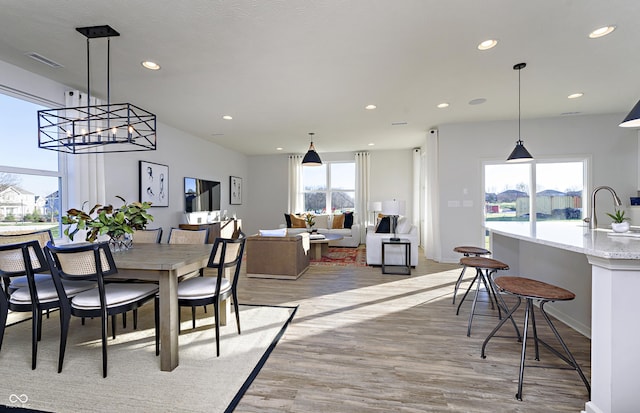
[423,130,442,261]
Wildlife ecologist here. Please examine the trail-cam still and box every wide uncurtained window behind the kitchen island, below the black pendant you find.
[484,160,586,221]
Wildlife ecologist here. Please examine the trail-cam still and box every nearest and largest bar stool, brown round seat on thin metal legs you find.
[482,276,591,400]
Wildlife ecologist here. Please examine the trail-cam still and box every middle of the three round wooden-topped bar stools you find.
[456,257,520,337]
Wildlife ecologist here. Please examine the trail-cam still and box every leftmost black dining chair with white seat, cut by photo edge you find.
[0,240,96,369]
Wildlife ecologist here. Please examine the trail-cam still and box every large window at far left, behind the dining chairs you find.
[0,93,62,237]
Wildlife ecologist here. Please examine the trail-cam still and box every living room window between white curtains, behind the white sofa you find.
[302,162,356,214]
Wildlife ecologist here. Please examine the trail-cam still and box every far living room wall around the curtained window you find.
[243,149,413,234]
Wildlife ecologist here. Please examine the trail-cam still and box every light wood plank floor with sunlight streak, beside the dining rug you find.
[236,246,591,413]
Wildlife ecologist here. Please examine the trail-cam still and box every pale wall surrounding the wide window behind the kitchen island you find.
[439,114,638,262]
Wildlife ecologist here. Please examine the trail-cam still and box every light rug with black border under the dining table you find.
[0,305,297,412]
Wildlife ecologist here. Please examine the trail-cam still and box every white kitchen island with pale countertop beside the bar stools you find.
[487,221,640,413]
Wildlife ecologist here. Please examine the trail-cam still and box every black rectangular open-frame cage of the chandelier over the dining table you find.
[38,103,156,154]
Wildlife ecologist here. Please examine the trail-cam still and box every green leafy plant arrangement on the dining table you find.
[62,196,153,242]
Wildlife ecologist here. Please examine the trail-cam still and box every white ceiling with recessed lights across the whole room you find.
[0,0,640,155]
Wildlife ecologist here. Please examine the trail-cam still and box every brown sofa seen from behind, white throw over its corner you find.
[246,233,310,280]
